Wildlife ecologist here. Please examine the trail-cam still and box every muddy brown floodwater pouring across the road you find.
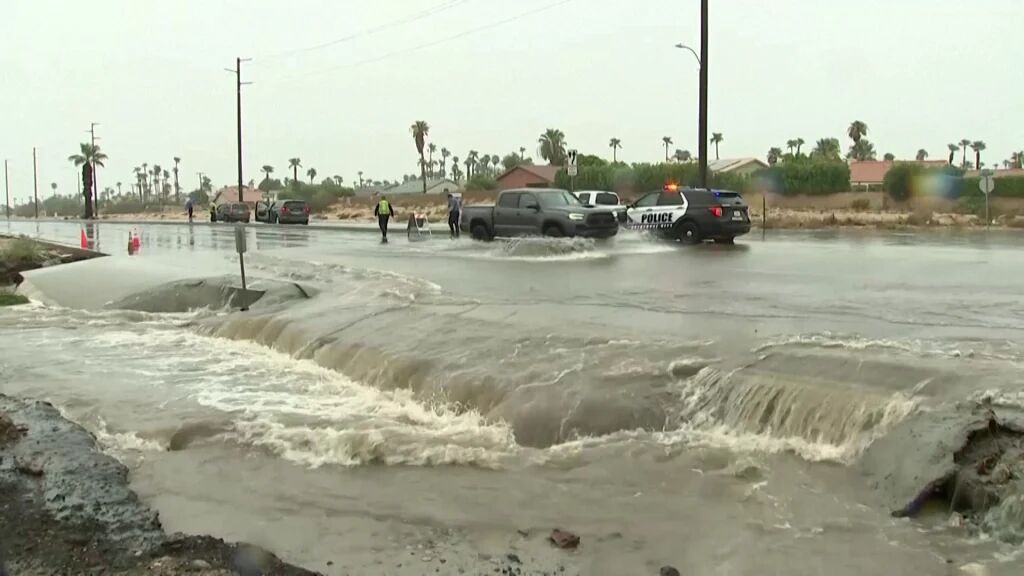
[0,217,1024,576]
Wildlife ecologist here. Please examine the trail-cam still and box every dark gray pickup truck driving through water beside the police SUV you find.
[462,189,618,241]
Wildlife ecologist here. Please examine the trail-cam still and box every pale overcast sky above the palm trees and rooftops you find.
[0,0,1024,200]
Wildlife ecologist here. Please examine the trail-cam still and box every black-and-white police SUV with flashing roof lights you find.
[620,184,751,244]
